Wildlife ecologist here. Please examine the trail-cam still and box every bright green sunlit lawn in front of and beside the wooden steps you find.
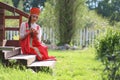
[0,49,103,80]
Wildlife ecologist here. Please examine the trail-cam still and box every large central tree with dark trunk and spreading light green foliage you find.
[0,0,110,45]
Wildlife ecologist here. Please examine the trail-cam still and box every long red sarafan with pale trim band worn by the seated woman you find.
[20,23,56,60]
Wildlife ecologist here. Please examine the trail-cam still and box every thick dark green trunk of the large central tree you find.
[56,0,84,45]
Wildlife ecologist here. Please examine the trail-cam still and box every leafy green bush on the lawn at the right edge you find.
[95,28,120,80]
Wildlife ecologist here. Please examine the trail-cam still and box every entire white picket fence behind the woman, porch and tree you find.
[5,28,100,47]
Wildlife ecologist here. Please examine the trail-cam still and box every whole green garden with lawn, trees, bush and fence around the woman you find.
[0,0,120,80]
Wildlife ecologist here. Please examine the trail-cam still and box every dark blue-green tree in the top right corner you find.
[96,0,120,25]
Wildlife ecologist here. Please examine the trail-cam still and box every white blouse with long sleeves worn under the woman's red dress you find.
[20,22,42,41]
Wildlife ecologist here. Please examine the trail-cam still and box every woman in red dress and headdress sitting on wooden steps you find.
[20,8,56,60]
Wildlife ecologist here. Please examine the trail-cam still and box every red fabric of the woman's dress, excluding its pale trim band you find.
[20,24,56,60]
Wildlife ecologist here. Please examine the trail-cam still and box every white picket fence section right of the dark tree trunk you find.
[73,28,100,47]
